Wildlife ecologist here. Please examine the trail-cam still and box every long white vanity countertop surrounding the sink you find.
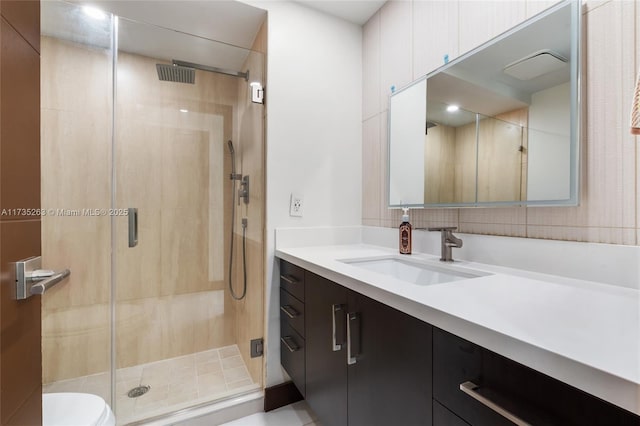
[276,244,640,415]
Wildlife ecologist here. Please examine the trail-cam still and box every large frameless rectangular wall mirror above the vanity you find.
[388,1,581,207]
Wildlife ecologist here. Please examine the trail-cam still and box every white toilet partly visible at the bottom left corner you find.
[42,392,116,426]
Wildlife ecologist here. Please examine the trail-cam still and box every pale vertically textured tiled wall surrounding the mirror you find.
[362,0,640,245]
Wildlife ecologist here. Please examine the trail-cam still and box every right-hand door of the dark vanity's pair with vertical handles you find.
[345,292,431,426]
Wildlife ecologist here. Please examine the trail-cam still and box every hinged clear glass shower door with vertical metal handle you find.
[113,18,263,423]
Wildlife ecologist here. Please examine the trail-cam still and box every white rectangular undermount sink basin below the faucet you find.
[341,256,490,285]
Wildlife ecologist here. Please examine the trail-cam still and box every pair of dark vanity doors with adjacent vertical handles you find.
[305,272,431,426]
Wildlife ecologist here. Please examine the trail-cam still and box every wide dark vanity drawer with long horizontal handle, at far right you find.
[433,328,640,426]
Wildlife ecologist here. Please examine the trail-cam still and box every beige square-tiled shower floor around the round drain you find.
[43,345,259,425]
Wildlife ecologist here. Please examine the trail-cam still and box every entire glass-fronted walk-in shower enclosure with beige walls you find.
[41,1,265,424]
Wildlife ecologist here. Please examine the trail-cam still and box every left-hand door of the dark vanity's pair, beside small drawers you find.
[305,272,347,426]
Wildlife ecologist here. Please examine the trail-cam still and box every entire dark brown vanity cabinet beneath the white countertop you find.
[280,261,640,426]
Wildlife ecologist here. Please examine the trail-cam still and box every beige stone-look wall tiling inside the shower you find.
[42,36,254,383]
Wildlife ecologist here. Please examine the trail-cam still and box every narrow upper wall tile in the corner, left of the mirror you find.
[362,12,381,120]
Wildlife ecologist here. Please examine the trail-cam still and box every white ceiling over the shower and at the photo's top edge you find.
[41,0,385,71]
